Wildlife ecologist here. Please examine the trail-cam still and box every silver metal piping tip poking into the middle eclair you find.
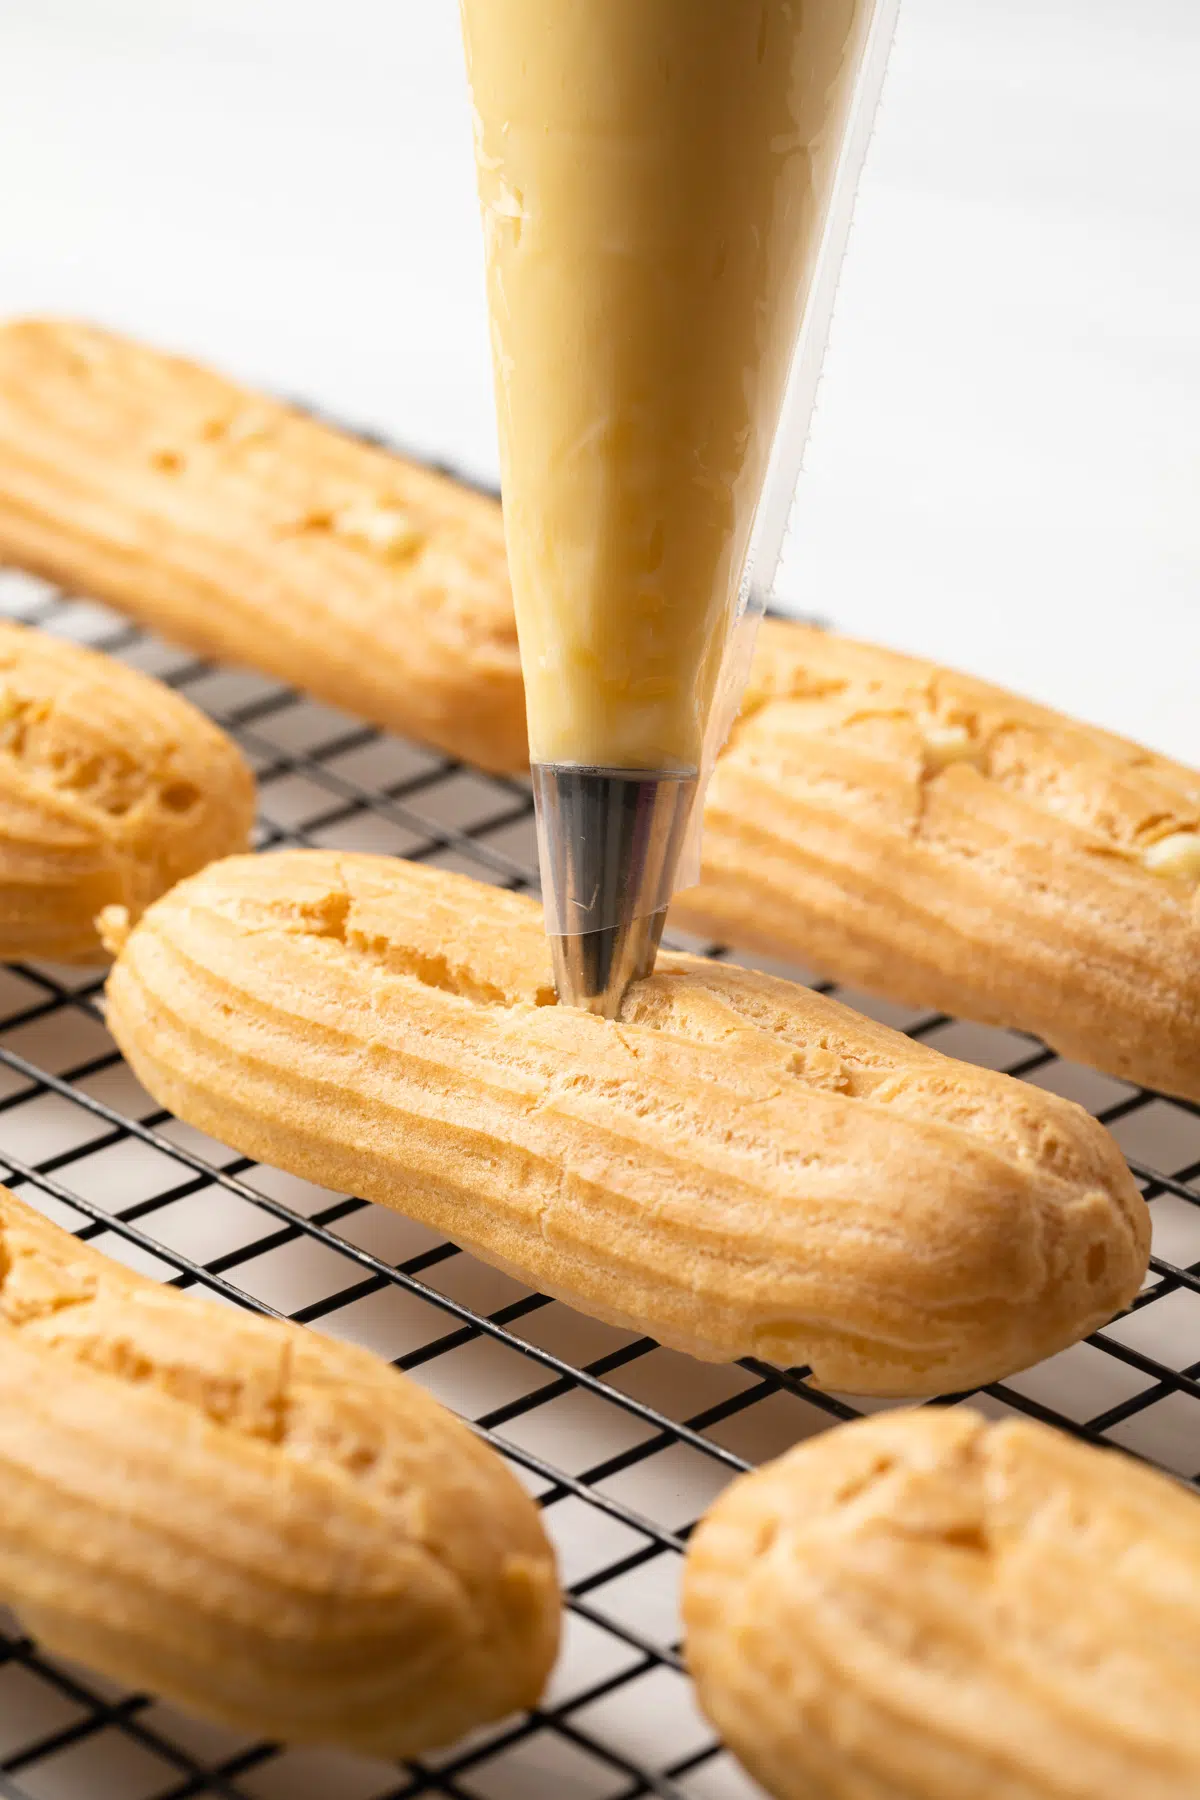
[533,763,696,1019]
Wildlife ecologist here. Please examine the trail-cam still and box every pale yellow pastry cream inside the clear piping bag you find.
[462,0,874,769]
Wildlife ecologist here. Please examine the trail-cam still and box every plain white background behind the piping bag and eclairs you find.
[0,0,1200,760]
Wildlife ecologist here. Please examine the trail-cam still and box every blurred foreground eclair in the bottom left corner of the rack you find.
[0,1190,558,1755]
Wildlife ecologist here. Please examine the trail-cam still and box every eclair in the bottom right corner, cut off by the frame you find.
[684,1408,1200,1800]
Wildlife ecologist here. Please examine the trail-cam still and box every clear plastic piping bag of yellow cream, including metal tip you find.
[461,0,900,1019]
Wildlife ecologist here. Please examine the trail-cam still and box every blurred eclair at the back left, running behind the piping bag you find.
[0,320,527,769]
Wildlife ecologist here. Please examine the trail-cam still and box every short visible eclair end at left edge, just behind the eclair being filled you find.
[0,621,254,963]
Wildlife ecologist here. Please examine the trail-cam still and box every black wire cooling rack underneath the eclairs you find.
[0,522,1200,1800]
